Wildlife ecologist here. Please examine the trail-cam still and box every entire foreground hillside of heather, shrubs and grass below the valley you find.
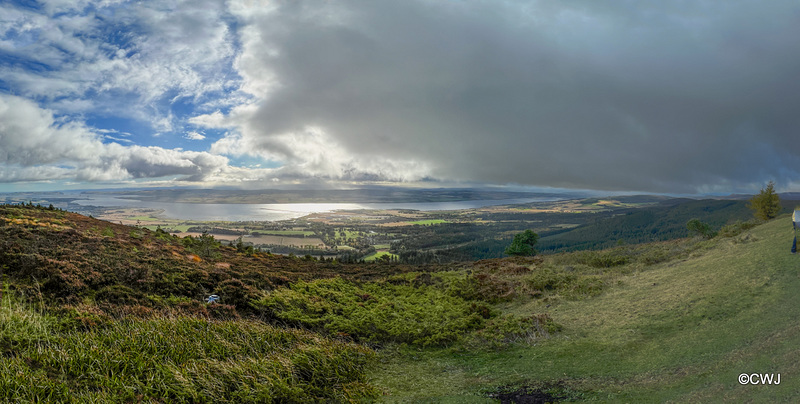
[0,205,800,403]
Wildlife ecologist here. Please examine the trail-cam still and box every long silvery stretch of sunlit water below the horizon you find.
[73,195,556,221]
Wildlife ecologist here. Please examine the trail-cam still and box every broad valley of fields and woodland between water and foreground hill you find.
[78,196,764,264]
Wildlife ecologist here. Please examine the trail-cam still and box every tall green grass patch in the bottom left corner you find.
[0,298,374,403]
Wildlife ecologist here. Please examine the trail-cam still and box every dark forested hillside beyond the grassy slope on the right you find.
[392,196,768,263]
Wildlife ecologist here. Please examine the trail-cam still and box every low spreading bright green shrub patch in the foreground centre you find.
[256,278,494,346]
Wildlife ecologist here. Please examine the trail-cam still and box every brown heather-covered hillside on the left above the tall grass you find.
[0,205,438,318]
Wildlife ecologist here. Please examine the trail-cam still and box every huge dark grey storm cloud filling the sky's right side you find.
[234,0,800,192]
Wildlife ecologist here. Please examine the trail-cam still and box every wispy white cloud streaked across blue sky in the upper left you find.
[0,0,238,130]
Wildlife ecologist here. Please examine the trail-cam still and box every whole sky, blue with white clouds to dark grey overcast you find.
[0,0,800,194]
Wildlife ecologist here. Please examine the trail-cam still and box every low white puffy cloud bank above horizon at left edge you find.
[0,95,228,182]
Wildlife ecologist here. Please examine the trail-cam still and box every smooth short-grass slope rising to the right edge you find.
[374,217,800,402]
